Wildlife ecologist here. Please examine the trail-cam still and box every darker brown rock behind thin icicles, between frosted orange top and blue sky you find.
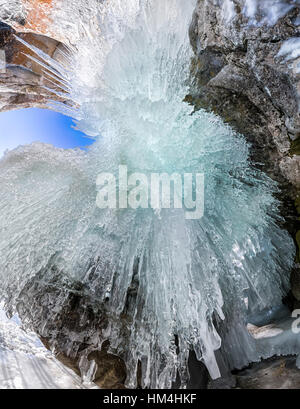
[0,22,68,112]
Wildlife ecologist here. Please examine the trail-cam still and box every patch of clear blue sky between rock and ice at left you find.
[0,108,93,157]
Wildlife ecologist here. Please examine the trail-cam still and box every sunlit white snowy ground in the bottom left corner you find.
[0,309,95,389]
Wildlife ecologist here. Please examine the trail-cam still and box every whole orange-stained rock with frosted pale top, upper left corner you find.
[0,0,92,112]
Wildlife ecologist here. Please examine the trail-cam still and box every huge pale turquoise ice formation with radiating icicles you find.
[0,0,294,388]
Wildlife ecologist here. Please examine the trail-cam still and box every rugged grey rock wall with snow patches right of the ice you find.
[187,0,300,191]
